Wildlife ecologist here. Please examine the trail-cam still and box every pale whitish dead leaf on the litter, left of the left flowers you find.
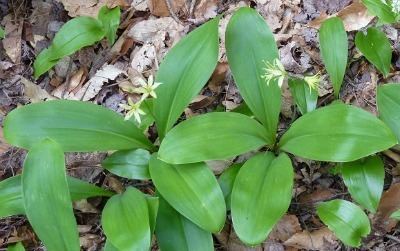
[73,64,126,101]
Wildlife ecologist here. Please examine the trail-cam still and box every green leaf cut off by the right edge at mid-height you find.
[377,84,400,141]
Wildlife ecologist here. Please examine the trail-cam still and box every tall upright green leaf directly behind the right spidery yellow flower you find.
[225,7,281,143]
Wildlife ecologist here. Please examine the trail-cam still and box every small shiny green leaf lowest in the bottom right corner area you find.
[317,200,371,247]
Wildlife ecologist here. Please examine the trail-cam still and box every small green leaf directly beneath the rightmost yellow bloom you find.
[288,78,318,115]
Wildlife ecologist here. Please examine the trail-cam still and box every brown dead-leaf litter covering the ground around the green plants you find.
[0,0,400,251]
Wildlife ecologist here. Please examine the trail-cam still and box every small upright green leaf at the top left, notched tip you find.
[97,6,121,45]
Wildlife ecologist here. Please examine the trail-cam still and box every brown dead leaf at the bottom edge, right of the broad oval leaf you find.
[283,227,338,250]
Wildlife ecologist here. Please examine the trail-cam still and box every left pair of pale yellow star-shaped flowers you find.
[119,75,161,124]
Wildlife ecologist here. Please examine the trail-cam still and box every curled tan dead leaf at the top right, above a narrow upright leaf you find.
[308,2,374,31]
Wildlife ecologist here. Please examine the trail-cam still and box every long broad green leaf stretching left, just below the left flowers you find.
[4,100,153,152]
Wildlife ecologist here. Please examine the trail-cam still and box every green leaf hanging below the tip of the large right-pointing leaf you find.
[342,156,385,213]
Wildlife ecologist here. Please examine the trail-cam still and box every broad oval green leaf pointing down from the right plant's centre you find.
[231,152,293,246]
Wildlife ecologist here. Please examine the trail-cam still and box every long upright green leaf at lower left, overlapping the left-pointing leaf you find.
[21,139,80,251]
